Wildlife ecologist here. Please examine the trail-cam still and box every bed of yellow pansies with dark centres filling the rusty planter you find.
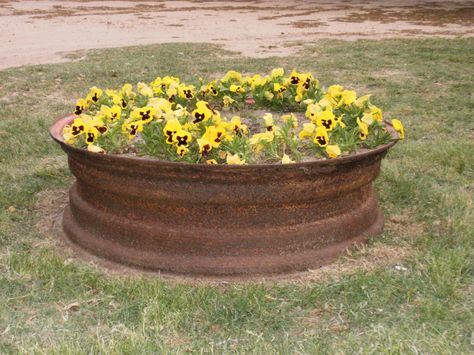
[63,68,405,164]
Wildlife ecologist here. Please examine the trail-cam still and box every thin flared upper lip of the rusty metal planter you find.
[49,114,397,171]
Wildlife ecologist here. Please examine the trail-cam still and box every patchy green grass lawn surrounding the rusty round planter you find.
[0,38,474,354]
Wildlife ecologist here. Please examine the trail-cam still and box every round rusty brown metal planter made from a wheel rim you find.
[50,116,394,277]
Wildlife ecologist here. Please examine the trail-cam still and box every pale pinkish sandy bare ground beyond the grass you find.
[0,0,474,69]
